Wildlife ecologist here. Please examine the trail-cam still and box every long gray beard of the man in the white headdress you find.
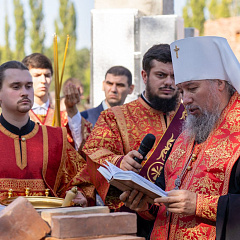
[183,109,221,144]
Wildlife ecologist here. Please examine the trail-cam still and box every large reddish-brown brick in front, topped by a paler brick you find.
[51,212,137,239]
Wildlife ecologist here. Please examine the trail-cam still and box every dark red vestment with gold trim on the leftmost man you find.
[0,124,94,205]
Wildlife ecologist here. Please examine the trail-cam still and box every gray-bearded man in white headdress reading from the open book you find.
[120,37,240,239]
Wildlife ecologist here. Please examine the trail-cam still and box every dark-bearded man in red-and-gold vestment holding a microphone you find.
[83,44,185,237]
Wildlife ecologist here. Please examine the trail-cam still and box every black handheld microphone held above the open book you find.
[133,133,156,164]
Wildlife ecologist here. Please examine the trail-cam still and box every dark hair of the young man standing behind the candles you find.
[22,53,53,75]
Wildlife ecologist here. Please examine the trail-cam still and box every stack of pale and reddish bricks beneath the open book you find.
[41,207,144,240]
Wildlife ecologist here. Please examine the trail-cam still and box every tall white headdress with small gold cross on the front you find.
[170,36,240,93]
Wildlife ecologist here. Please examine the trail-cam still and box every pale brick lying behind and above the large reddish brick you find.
[40,206,109,226]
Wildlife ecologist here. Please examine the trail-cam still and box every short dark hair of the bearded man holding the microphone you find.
[142,44,172,76]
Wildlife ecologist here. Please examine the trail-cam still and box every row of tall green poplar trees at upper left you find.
[0,0,90,97]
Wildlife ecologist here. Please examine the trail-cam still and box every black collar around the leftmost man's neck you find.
[0,114,35,136]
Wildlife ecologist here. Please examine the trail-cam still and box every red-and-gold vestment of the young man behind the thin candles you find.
[29,107,92,149]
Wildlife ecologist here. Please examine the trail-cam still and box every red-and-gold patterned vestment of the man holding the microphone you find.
[83,98,184,209]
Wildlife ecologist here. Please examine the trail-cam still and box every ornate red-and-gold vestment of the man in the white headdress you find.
[151,92,240,239]
